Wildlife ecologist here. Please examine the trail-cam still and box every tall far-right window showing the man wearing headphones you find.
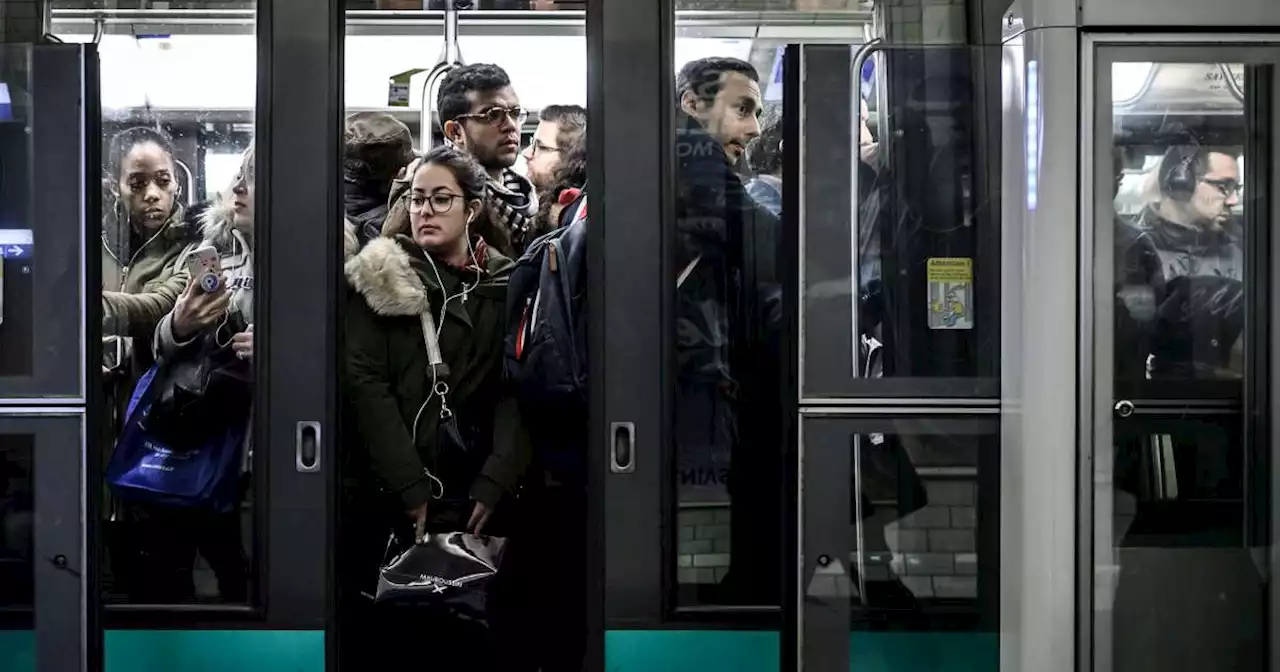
[1089,55,1275,669]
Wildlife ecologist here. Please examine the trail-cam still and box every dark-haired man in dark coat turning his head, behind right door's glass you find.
[675,58,783,604]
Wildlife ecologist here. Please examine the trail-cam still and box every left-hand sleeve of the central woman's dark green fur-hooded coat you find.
[344,293,431,509]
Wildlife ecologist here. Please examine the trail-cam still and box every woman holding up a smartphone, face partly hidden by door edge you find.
[119,148,256,604]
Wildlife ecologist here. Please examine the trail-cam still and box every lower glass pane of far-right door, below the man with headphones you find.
[1094,416,1266,671]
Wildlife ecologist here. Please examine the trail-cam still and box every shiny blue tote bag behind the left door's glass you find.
[106,364,248,511]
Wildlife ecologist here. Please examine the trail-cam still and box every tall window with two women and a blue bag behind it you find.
[71,24,264,608]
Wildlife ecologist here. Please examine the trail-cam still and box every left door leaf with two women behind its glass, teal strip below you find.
[37,3,342,672]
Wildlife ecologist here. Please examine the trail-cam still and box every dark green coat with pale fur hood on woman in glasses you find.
[346,236,530,525]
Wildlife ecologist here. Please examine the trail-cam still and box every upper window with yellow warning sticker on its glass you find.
[801,45,1000,398]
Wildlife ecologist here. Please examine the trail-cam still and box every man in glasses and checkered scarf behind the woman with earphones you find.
[435,63,538,259]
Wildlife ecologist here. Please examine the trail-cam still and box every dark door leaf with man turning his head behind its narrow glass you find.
[586,0,798,672]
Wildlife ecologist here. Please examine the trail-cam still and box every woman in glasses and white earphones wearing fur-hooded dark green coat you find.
[346,147,529,669]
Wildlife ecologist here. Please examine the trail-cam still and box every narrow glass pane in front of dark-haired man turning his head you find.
[668,6,790,607]
